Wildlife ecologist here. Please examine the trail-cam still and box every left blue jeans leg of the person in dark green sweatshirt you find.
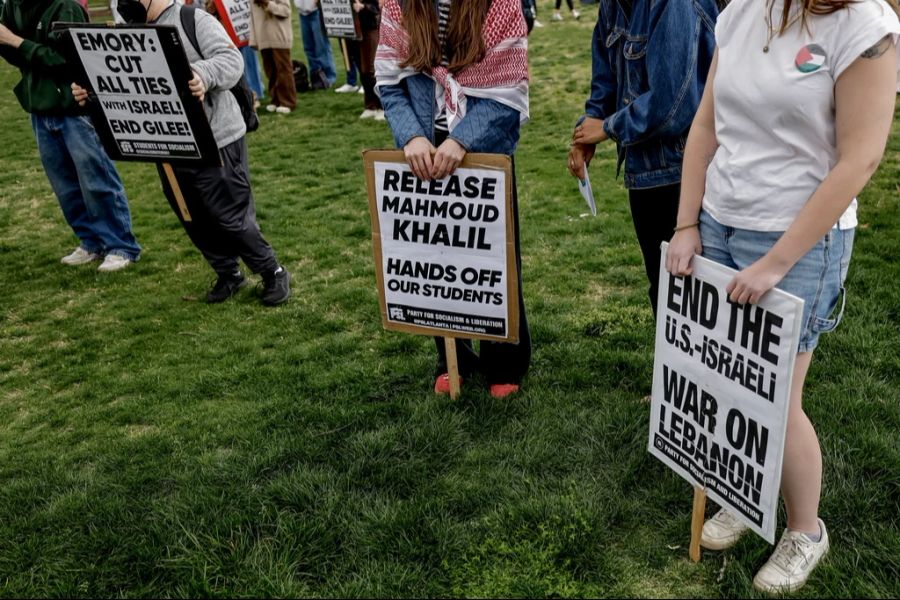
[31,115,103,254]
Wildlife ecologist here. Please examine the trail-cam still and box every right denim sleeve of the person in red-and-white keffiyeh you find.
[449,97,520,154]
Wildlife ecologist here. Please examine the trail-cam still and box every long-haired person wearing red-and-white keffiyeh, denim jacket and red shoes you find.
[375,0,531,398]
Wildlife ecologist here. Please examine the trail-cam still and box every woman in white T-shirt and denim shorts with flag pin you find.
[666,0,900,593]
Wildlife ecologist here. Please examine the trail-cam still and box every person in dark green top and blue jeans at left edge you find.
[0,0,141,272]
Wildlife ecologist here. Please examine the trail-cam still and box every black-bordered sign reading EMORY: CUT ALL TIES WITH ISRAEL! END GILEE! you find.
[68,25,219,164]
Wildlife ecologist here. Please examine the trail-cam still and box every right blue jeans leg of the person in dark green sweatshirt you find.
[61,117,141,261]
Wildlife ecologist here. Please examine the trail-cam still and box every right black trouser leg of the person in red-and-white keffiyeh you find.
[481,160,531,385]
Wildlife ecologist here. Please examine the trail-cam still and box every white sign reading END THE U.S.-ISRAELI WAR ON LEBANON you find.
[649,244,803,543]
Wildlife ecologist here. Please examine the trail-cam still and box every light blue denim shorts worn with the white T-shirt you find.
[700,210,856,352]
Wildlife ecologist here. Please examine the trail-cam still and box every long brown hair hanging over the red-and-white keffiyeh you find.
[400,0,490,73]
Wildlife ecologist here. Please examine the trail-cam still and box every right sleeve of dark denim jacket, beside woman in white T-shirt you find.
[603,0,715,146]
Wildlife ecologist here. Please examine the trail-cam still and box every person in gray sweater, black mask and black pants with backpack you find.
[73,0,291,306]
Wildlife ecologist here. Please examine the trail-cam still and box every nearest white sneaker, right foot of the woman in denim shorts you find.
[753,519,828,594]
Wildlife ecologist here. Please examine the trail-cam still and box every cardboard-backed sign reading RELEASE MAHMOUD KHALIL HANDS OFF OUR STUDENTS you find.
[365,151,519,341]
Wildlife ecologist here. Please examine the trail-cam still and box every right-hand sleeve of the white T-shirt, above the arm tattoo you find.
[831,0,900,80]
